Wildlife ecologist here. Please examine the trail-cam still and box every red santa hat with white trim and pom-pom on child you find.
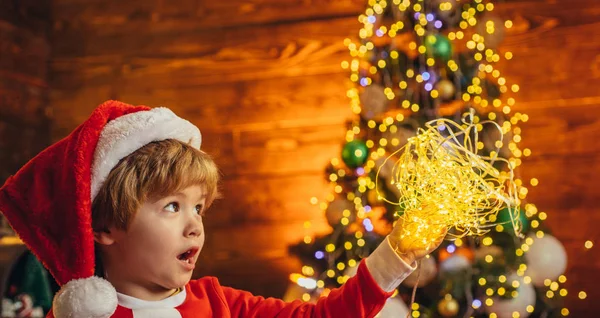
[0,101,201,318]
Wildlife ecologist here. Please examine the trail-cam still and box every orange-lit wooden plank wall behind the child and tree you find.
[50,0,600,317]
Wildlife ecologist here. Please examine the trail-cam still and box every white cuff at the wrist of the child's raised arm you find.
[366,237,417,292]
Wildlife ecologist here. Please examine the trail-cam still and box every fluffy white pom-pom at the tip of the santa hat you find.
[52,276,118,318]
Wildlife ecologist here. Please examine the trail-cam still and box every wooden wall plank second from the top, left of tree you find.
[55,14,358,61]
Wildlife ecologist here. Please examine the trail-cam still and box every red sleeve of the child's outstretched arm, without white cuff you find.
[216,261,392,318]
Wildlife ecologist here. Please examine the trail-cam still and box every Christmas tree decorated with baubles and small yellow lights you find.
[285,0,569,317]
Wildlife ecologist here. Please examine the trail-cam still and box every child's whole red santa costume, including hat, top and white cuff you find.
[0,101,414,318]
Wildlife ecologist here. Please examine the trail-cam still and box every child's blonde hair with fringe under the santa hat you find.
[92,139,219,232]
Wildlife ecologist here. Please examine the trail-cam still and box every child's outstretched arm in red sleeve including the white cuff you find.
[216,239,422,318]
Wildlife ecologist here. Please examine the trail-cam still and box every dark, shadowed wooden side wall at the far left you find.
[0,0,51,183]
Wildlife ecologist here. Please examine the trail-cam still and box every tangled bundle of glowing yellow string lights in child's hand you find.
[376,113,521,247]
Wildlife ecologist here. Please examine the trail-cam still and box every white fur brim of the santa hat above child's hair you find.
[91,107,202,201]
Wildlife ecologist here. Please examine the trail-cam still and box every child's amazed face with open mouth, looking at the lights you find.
[104,185,206,292]
